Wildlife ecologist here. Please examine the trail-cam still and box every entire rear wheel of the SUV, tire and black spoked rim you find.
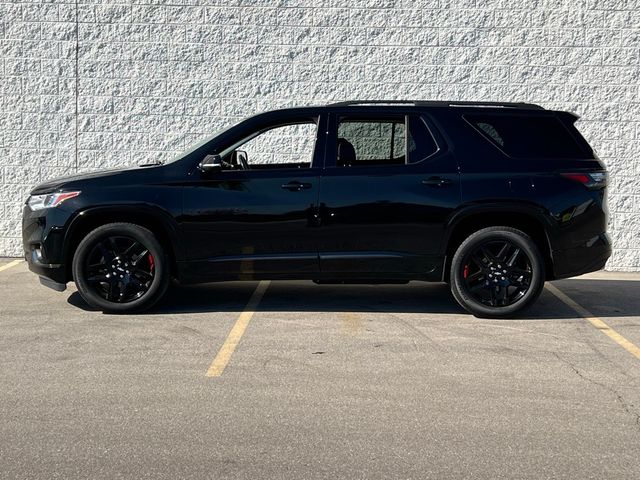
[449,226,545,318]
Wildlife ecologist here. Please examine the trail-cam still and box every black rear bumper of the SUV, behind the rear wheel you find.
[551,233,611,279]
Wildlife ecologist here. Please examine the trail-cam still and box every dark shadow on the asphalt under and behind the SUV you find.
[68,279,640,320]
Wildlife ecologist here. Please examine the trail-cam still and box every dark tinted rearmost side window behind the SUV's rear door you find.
[464,114,592,158]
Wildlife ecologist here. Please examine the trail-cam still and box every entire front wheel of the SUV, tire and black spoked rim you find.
[72,223,170,313]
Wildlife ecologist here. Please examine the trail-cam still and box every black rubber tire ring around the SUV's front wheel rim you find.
[72,223,169,313]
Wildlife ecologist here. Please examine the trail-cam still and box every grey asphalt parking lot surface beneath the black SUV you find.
[0,259,640,479]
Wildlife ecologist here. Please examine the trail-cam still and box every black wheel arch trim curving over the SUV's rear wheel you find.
[443,204,553,280]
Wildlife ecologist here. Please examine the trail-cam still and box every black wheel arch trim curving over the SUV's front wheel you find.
[62,205,181,281]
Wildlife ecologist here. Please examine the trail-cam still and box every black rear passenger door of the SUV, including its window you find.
[318,113,460,279]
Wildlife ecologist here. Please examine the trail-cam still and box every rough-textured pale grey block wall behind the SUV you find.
[0,0,640,270]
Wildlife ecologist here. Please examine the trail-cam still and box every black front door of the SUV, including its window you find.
[181,117,322,281]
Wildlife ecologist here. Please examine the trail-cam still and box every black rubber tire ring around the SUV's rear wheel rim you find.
[450,227,545,318]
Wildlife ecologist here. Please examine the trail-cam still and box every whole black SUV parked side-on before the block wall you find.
[23,101,611,317]
